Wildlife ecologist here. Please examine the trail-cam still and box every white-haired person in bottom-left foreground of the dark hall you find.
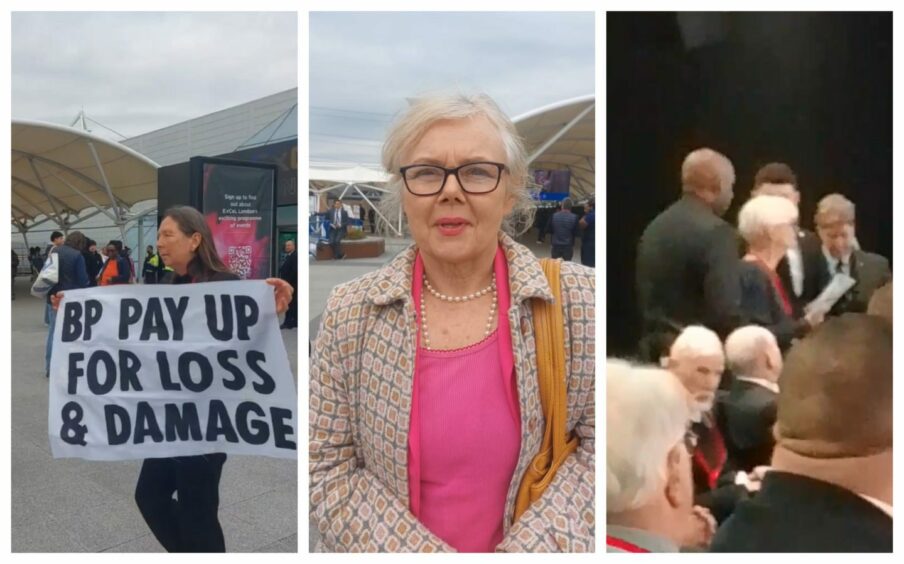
[606,360,715,552]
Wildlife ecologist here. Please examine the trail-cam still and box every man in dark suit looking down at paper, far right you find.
[816,194,891,315]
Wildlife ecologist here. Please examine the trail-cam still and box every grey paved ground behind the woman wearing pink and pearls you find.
[308,231,560,552]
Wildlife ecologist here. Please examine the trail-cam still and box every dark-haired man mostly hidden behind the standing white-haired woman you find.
[750,163,822,319]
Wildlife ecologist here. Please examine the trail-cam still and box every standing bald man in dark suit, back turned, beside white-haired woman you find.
[637,145,741,356]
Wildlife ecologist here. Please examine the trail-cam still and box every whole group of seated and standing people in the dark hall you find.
[606,149,892,552]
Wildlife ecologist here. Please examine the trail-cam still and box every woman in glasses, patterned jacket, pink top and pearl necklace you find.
[310,95,594,552]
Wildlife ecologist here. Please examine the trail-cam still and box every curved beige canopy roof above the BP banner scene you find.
[11,120,158,230]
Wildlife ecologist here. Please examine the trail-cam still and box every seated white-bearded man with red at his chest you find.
[666,325,747,523]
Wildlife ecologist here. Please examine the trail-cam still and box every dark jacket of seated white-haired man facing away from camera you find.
[722,378,778,472]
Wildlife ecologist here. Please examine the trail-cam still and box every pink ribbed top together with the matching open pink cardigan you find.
[408,248,521,552]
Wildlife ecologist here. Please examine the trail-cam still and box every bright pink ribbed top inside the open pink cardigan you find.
[418,333,521,552]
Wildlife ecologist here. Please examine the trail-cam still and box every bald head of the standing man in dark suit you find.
[681,148,735,215]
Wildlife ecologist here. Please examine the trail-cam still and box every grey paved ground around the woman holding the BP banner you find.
[11,277,298,552]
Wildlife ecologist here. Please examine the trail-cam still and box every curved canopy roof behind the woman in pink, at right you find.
[512,95,596,198]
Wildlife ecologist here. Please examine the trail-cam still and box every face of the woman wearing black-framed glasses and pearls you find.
[402,116,514,263]
